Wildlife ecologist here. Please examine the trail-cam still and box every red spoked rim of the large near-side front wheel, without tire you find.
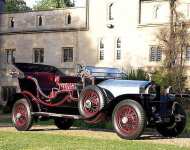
[116,105,139,135]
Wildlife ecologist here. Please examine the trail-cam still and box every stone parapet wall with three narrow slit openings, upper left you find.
[0,7,86,34]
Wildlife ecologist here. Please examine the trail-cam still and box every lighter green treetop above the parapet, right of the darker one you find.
[34,0,74,10]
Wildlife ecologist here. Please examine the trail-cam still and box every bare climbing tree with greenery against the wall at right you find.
[153,0,190,93]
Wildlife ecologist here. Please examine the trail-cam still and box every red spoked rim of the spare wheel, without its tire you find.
[82,90,100,117]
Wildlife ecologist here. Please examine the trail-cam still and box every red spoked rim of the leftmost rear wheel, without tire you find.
[13,104,28,127]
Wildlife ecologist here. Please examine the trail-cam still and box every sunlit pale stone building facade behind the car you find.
[0,0,190,73]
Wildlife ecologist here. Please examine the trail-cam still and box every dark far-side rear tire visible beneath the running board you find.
[54,118,74,130]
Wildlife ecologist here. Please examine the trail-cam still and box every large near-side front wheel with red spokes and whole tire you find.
[112,100,146,140]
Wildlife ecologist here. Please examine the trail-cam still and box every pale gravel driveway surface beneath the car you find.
[0,126,190,149]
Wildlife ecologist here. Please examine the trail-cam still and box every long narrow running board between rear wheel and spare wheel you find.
[32,112,83,120]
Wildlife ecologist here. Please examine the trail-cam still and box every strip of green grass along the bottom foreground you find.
[0,131,188,150]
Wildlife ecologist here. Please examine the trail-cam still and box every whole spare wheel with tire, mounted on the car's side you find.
[78,85,105,119]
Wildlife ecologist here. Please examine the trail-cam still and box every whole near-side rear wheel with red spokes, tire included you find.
[12,99,32,131]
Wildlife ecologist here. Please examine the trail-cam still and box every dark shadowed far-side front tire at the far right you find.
[156,103,186,137]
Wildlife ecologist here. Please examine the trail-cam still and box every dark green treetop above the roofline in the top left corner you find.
[4,0,31,12]
